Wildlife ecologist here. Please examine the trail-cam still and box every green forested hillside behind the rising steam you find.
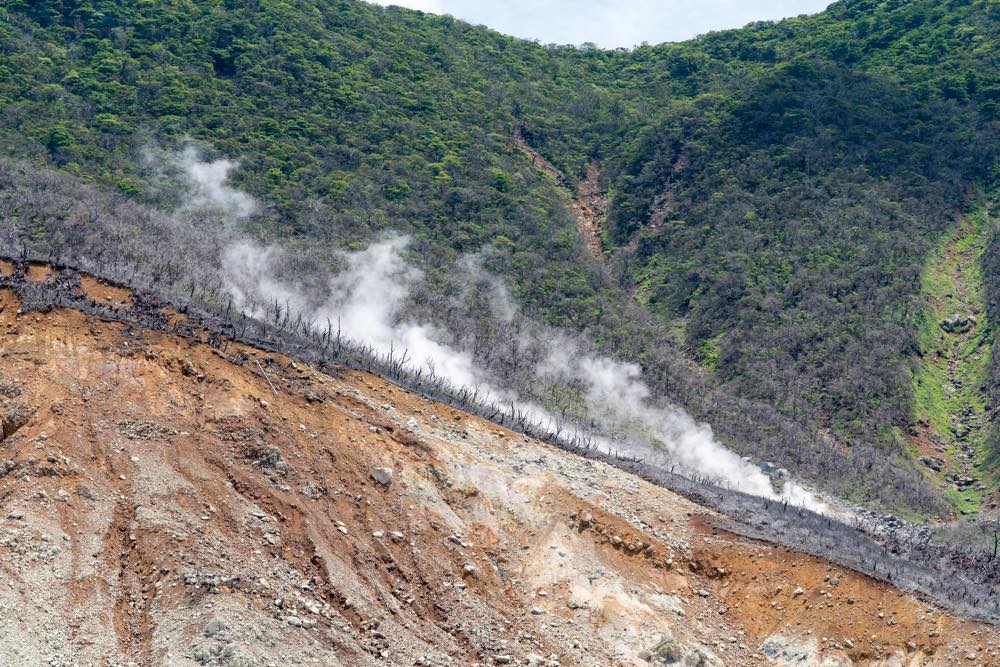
[0,0,1000,512]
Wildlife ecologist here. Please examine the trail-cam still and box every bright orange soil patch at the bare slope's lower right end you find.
[696,530,998,665]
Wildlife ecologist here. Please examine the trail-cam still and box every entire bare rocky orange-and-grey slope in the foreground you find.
[0,290,1000,667]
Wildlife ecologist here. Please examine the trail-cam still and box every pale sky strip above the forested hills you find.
[373,0,831,49]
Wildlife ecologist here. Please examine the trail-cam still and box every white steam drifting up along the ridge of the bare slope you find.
[175,149,826,512]
